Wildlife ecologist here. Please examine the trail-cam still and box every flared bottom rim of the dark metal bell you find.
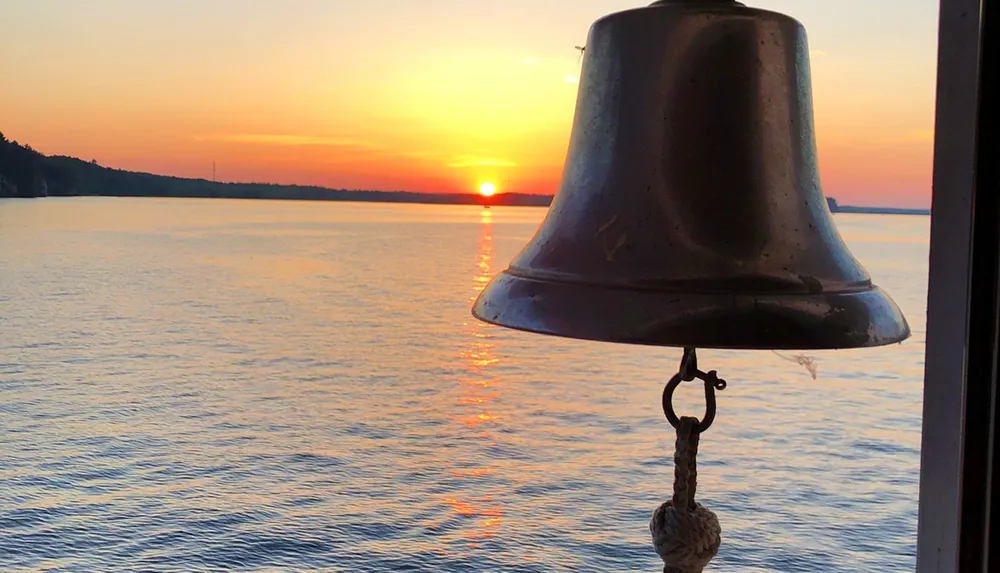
[471,271,912,350]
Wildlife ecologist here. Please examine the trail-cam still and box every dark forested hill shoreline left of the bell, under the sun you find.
[0,133,552,206]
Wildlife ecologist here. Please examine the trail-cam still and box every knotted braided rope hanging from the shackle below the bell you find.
[649,417,722,573]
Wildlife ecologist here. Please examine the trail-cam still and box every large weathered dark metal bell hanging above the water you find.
[473,0,910,349]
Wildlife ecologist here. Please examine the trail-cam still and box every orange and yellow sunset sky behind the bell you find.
[0,0,937,206]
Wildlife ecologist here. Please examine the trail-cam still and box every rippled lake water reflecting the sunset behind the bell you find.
[0,199,929,573]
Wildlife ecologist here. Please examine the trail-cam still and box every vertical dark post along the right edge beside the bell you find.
[917,0,1000,573]
